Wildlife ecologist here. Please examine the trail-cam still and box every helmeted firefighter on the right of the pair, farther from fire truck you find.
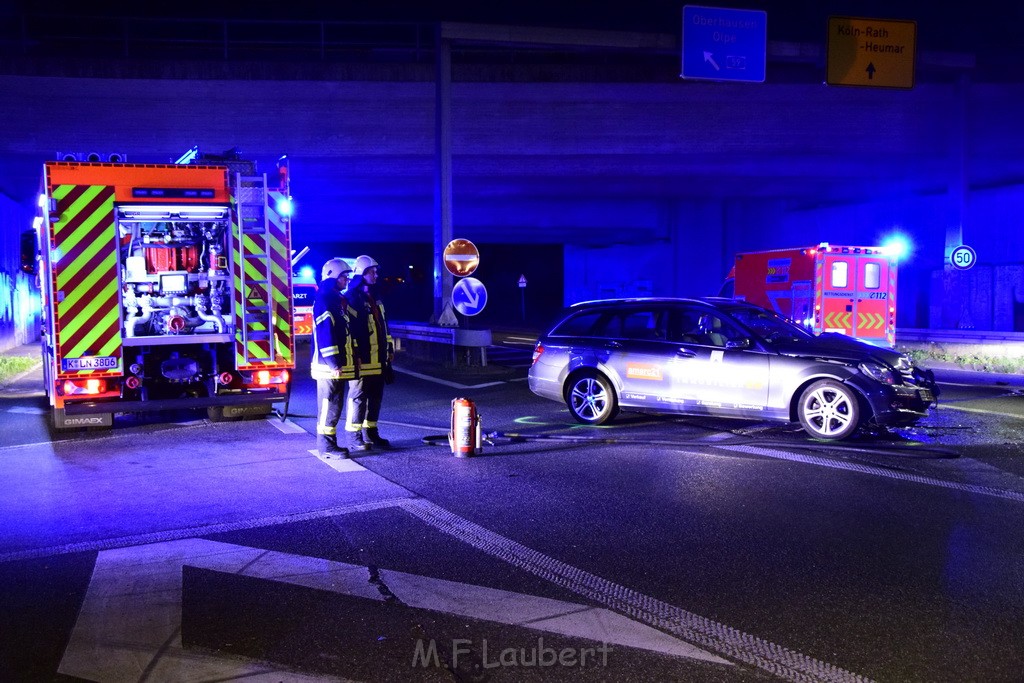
[345,255,394,451]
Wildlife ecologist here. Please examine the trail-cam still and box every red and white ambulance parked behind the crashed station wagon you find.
[724,242,896,346]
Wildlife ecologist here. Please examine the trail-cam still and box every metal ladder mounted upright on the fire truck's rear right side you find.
[234,173,275,364]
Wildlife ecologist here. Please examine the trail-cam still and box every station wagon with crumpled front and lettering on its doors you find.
[529,298,938,439]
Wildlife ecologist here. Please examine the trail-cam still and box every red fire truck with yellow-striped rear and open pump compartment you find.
[35,153,295,429]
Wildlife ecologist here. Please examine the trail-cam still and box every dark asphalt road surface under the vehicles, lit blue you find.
[0,344,1024,681]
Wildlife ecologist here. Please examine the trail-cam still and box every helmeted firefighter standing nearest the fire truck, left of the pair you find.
[310,258,356,456]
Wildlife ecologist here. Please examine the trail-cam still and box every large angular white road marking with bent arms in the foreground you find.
[58,539,730,681]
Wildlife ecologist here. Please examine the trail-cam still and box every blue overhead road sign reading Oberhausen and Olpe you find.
[680,5,768,83]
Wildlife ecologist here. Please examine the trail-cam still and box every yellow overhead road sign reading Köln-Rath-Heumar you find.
[826,16,918,88]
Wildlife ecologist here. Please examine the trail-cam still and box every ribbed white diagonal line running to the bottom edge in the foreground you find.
[401,499,869,683]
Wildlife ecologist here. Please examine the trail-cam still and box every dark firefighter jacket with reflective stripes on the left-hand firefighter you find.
[310,279,355,380]
